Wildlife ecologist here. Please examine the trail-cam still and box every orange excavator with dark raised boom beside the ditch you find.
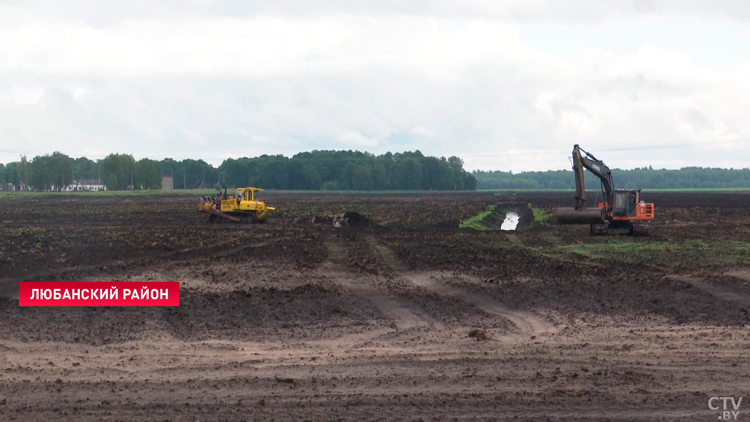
[555,145,654,236]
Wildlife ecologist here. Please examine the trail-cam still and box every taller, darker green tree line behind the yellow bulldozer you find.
[0,151,477,191]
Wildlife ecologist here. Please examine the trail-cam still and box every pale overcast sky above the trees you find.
[0,0,750,172]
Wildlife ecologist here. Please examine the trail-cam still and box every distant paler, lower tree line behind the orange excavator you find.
[472,167,750,190]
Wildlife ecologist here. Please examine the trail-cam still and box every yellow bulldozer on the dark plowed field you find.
[198,187,276,224]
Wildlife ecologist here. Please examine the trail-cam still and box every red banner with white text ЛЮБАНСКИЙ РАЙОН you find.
[18,281,180,306]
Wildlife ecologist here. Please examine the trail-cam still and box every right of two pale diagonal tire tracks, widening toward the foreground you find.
[367,236,556,340]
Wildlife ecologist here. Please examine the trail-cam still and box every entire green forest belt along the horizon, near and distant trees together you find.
[5,151,750,191]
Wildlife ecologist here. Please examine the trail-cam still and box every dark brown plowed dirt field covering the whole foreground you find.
[0,192,750,422]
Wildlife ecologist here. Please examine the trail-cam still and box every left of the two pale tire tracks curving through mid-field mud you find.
[324,235,434,332]
